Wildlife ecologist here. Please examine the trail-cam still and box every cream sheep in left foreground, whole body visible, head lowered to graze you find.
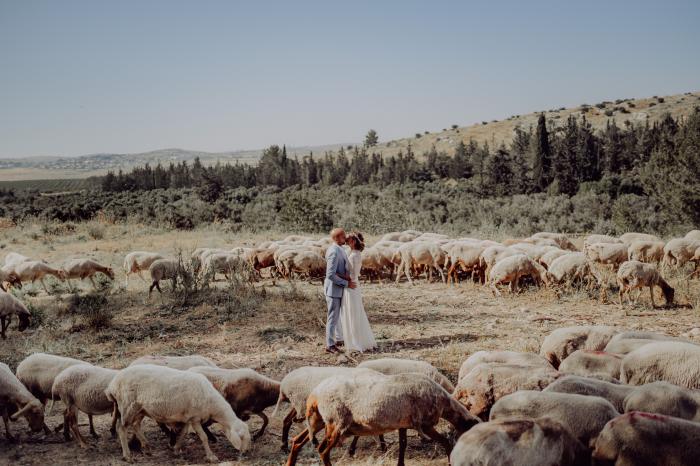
[105,364,250,462]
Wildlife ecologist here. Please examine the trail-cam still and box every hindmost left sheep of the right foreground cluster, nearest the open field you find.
[540,325,619,368]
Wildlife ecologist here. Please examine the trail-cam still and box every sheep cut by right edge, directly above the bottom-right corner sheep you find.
[624,382,700,422]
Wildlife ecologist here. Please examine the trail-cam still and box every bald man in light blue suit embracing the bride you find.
[323,228,357,353]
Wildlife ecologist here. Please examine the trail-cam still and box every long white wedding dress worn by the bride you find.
[340,250,377,352]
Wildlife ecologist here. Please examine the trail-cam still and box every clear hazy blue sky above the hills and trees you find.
[0,0,700,157]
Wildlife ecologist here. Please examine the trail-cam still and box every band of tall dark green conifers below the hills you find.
[90,108,700,228]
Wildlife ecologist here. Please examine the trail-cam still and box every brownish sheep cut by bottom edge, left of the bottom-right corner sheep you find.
[450,417,589,466]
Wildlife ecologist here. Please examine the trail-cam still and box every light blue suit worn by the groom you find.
[323,244,348,348]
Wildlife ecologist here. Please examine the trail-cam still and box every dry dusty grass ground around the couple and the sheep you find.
[0,224,700,465]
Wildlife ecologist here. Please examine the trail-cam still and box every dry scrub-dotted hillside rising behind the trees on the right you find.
[376,92,700,156]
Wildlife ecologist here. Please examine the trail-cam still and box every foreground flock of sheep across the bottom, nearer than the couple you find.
[0,326,700,466]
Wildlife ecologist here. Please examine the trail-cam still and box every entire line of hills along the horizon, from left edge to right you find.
[0,92,700,182]
